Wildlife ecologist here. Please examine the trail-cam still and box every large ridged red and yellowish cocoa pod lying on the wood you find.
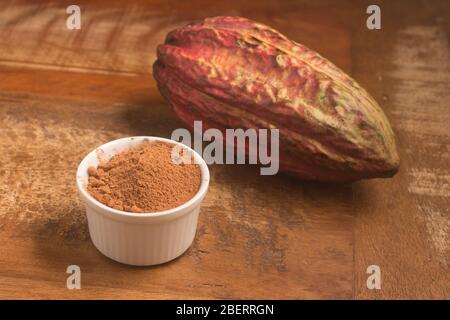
[153,17,399,182]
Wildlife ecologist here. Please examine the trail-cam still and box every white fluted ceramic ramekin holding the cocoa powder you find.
[77,137,209,266]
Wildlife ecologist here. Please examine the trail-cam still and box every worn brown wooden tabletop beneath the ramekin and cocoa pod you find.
[0,0,450,299]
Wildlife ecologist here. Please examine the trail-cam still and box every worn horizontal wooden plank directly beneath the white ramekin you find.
[0,73,353,298]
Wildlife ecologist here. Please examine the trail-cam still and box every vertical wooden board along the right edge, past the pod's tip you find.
[353,2,450,299]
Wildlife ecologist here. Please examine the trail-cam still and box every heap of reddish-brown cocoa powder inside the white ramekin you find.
[87,141,201,213]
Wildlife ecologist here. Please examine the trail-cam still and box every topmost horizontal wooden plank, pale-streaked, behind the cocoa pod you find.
[0,0,350,76]
